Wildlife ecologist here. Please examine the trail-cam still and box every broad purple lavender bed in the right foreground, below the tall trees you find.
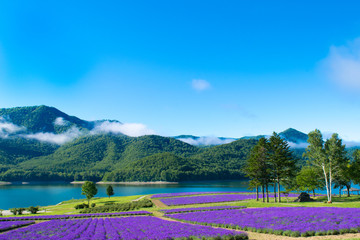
[165,207,360,237]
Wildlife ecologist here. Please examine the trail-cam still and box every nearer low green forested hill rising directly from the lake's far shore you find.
[0,134,256,181]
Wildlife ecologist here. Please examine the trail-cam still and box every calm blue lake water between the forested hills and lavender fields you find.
[0,181,249,209]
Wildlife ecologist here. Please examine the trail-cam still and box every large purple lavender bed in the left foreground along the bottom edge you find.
[0,216,248,240]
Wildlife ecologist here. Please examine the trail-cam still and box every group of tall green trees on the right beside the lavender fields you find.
[244,129,360,203]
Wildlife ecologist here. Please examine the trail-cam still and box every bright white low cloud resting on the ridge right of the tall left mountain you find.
[91,121,156,137]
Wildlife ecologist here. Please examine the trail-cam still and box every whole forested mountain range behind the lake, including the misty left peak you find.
[0,106,316,181]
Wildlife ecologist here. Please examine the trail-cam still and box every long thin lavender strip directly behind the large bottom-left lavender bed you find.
[0,211,152,223]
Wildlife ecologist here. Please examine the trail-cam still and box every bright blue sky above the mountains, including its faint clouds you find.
[0,0,360,141]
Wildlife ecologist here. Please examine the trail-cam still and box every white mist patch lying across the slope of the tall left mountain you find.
[21,127,83,145]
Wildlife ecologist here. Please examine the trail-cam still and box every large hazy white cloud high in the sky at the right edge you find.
[321,38,360,90]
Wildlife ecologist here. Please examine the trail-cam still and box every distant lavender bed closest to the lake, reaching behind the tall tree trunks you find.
[159,193,297,206]
